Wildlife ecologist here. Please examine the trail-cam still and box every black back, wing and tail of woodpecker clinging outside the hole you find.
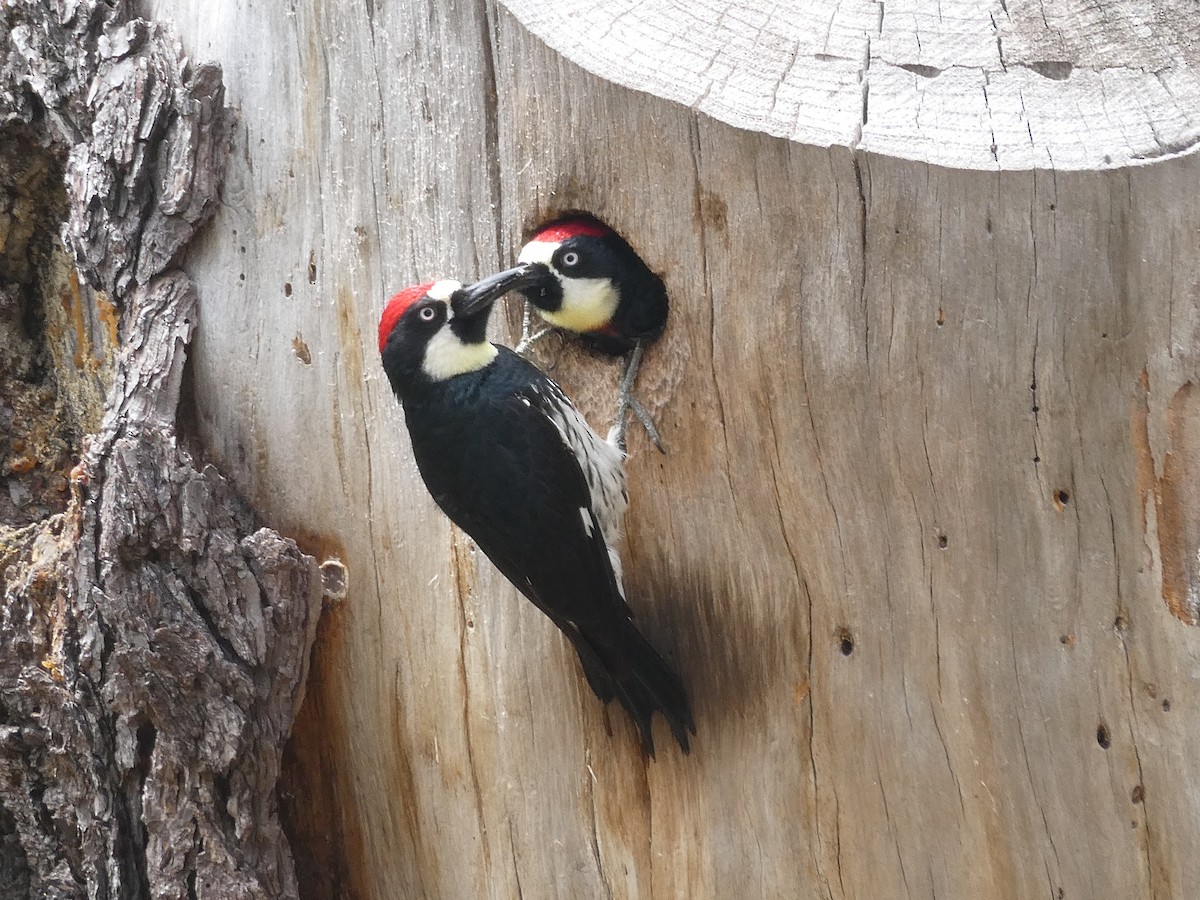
[406,350,696,755]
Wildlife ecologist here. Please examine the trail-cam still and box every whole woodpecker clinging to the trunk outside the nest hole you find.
[379,265,696,756]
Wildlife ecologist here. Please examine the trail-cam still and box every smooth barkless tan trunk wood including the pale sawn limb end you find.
[0,0,1200,900]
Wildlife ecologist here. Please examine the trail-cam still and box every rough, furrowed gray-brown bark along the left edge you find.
[0,0,322,900]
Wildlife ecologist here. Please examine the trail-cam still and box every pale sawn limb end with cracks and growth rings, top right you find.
[499,0,1200,170]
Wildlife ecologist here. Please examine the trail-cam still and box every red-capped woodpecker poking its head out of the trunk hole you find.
[517,212,670,451]
